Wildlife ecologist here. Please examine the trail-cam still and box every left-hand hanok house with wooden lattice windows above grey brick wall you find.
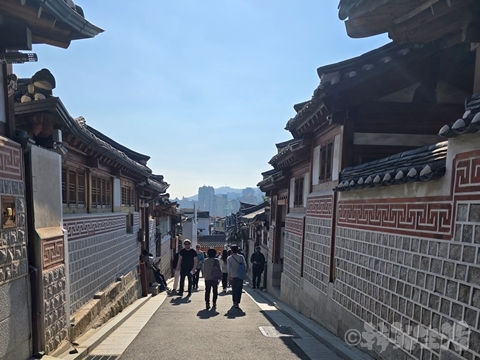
[15,93,169,352]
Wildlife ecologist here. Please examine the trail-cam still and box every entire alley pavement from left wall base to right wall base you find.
[57,280,371,360]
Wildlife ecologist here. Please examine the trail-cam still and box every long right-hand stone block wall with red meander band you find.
[281,135,480,360]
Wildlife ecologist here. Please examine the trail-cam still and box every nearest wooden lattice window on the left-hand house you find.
[62,167,87,208]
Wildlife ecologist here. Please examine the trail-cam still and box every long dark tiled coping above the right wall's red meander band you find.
[334,141,448,191]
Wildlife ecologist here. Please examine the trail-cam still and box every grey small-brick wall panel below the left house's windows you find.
[64,213,140,315]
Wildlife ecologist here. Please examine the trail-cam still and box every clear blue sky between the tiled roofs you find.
[14,0,389,198]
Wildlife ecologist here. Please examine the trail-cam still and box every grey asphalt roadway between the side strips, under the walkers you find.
[121,281,310,360]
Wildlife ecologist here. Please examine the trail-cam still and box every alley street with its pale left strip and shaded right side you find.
[84,279,346,360]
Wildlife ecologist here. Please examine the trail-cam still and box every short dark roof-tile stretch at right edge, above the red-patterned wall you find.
[438,94,480,138]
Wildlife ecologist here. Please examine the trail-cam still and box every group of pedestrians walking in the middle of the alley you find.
[142,239,265,309]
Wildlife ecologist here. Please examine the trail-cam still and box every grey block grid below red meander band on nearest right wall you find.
[333,198,480,360]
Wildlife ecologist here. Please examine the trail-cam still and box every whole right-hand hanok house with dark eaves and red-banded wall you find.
[259,1,480,359]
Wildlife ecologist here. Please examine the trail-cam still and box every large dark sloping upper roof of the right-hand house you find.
[285,43,438,137]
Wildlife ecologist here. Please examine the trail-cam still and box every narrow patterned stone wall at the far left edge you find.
[0,137,32,360]
